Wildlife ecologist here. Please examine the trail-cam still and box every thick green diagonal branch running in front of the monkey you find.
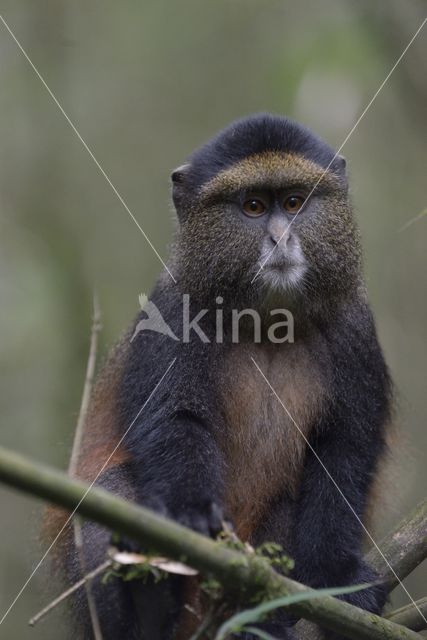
[0,448,419,640]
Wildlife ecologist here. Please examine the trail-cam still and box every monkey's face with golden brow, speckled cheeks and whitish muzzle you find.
[172,161,360,306]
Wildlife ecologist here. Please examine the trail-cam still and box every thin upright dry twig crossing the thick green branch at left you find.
[68,292,102,640]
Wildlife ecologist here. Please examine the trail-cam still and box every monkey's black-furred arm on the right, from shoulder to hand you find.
[293,300,391,596]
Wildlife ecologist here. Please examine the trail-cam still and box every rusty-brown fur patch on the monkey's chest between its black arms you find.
[222,343,327,539]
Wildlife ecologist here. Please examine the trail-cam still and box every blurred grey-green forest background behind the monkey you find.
[0,0,427,640]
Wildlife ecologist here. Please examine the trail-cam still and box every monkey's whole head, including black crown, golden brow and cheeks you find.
[172,114,360,316]
